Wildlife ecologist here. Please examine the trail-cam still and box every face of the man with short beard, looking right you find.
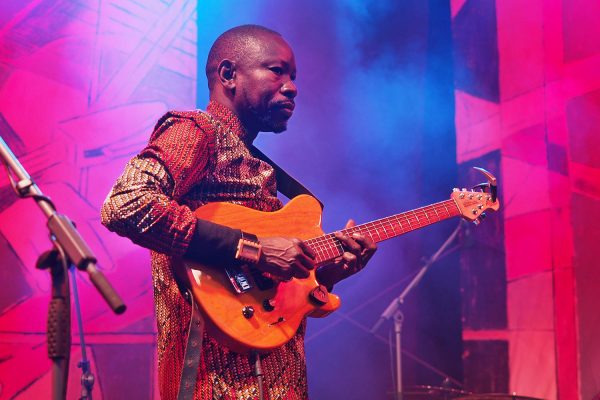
[235,35,298,133]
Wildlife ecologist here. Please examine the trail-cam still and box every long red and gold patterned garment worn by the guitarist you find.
[101,102,307,400]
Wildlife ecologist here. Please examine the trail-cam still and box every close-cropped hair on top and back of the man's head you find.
[206,25,281,90]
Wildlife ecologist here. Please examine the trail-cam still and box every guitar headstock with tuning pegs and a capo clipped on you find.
[450,167,500,224]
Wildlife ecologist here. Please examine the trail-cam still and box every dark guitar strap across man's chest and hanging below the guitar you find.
[175,112,324,400]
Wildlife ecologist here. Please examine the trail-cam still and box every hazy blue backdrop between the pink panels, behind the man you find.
[197,0,461,399]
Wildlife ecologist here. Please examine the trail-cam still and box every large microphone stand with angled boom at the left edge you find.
[0,136,126,400]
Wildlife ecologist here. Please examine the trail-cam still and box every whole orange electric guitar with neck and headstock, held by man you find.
[176,168,500,352]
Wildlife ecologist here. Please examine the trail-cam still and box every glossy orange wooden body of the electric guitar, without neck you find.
[176,195,340,352]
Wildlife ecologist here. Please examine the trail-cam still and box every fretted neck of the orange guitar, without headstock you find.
[304,199,461,265]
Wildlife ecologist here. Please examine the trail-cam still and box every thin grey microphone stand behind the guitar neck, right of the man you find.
[371,220,463,400]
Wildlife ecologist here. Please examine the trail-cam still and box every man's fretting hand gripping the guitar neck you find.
[317,220,377,288]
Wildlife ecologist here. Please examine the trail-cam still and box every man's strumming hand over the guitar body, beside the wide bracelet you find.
[256,237,316,281]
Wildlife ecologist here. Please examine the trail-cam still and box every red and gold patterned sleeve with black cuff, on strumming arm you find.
[101,114,240,261]
